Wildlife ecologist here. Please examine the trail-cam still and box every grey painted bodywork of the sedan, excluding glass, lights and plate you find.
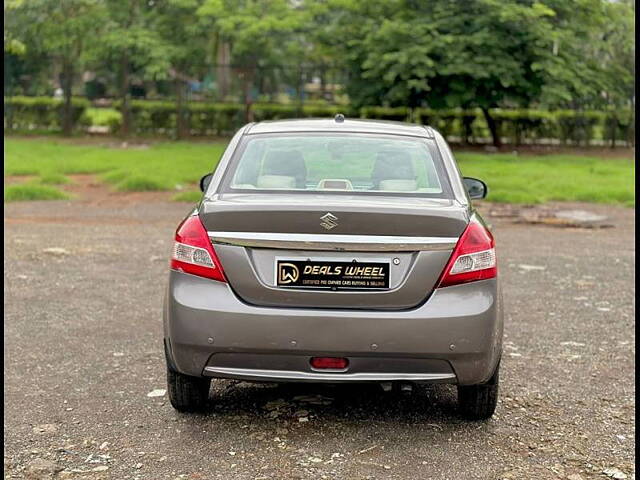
[163,120,503,385]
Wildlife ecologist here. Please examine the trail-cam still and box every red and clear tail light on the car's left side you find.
[171,215,227,282]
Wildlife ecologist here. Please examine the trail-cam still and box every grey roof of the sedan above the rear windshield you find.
[244,118,434,138]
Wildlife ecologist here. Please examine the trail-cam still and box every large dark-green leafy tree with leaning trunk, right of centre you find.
[318,0,554,145]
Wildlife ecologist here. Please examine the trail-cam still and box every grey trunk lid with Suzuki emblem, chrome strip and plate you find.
[200,193,469,309]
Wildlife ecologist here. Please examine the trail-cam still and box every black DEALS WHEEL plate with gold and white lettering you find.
[276,260,389,290]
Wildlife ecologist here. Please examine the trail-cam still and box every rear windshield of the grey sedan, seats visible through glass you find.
[224,133,450,198]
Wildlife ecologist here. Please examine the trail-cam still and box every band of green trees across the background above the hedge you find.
[4,0,635,145]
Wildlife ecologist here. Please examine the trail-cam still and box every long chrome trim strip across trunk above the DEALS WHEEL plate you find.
[208,232,458,252]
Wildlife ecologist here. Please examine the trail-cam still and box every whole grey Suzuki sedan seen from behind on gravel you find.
[164,115,503,420]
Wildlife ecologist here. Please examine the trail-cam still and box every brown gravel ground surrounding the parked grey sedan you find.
[4,197,635,480]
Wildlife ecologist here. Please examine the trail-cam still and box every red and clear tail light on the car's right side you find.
[439,220,498,287]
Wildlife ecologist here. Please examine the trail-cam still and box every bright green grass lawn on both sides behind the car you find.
[4,138,635,206]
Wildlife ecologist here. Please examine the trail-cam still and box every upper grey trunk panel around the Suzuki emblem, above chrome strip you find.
[200,193,469,238]
